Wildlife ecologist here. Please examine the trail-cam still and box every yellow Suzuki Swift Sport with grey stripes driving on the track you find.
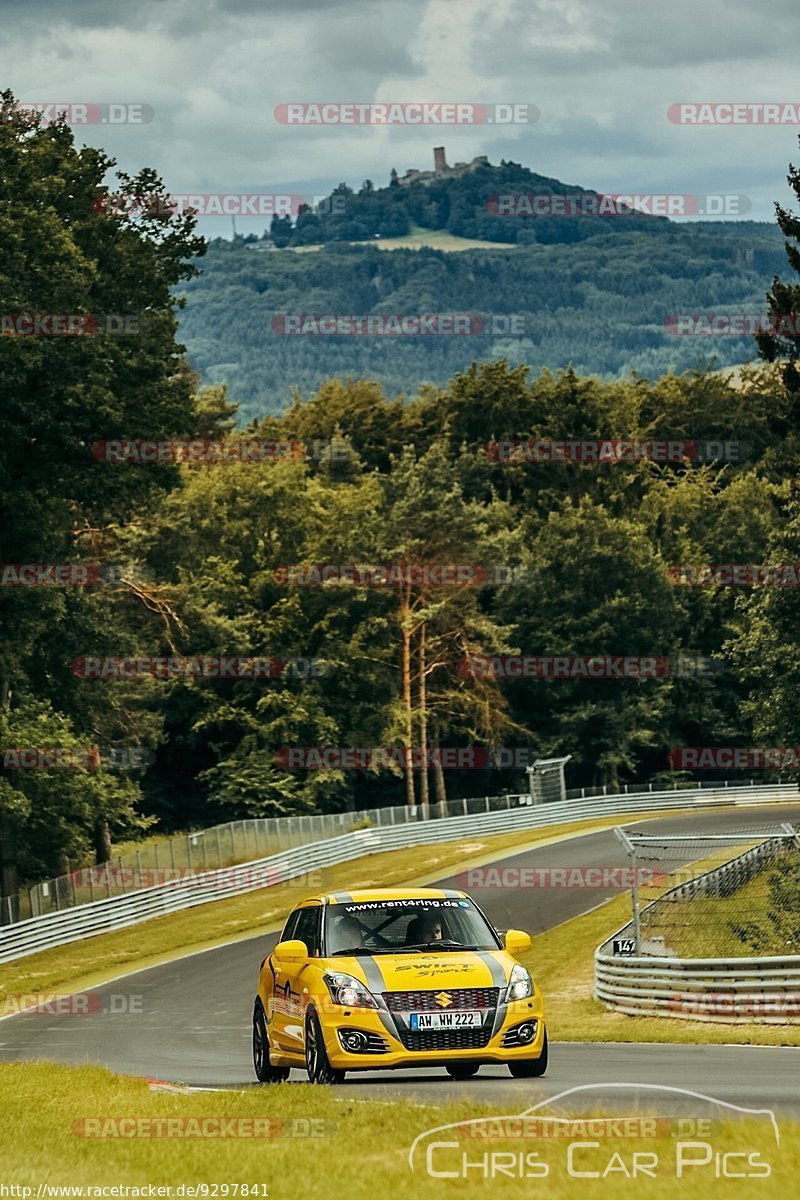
[253,888,547,1084]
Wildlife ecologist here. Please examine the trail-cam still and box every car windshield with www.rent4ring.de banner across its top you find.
[325,898,500,955]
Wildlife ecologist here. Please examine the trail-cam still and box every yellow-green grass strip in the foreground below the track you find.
[0,1063,800,1200]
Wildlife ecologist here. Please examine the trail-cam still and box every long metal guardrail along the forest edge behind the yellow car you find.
[0,785,799,962]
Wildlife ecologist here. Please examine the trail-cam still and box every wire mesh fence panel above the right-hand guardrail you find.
[612,823,800,959]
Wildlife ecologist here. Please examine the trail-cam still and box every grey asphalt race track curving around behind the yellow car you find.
[0,804,800,1116]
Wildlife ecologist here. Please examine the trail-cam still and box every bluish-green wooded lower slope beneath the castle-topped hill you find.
[180,218,786,419]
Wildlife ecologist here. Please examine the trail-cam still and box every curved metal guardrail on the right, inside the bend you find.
[595,839,800,1025]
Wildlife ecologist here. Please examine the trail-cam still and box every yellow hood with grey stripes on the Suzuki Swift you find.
[327,950,515,992]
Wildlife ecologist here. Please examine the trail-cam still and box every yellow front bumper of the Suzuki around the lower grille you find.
[311,997,545,1070]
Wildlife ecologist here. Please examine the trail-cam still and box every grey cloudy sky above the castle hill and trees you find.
[0,0,800,236]
